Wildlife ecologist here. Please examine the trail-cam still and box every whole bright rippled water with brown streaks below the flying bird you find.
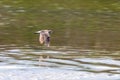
[0,45,120,80]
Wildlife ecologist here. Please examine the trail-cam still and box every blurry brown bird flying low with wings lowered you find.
[35,30,53,47]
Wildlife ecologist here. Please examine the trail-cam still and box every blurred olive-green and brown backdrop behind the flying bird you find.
[0,0,120,50]
